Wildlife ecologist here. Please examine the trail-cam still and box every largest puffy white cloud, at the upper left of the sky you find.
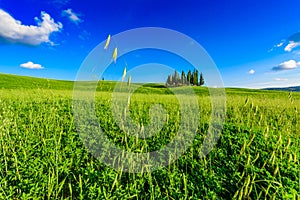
[0,9,63,45]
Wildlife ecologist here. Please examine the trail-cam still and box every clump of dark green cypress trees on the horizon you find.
[166,70,204,87]
